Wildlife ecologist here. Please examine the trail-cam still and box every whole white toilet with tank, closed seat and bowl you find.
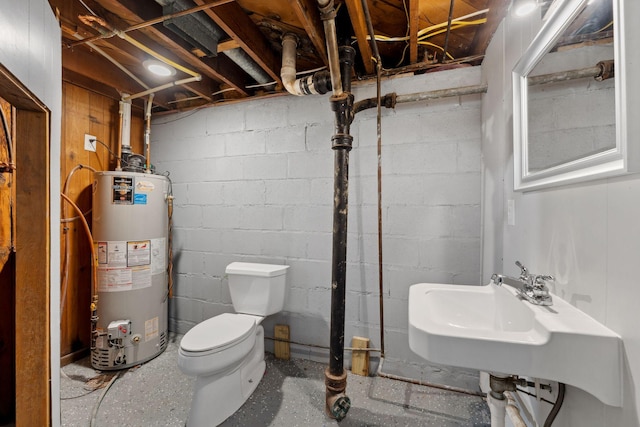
[178,262,289,427]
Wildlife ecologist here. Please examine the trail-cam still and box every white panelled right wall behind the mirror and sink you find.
[482,1,640,427]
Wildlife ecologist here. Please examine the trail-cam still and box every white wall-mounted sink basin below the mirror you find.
[409,283,622,406]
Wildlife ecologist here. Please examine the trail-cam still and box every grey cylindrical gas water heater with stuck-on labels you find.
[91,171,170,370]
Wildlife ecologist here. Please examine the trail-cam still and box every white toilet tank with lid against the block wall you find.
[225,262,289,316]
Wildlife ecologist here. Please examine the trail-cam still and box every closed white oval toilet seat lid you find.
[180,313,256,356]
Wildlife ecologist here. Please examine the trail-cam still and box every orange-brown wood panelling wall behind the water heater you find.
[60,82,144,364]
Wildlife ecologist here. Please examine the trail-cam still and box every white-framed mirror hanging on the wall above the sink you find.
[513,0,640,191]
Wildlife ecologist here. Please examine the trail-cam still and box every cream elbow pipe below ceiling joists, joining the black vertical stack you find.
[280,33,332,96]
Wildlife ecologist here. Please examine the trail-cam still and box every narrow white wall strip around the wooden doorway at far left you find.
[0,0,62,427]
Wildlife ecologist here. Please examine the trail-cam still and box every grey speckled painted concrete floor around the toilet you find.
[61,334,491,427]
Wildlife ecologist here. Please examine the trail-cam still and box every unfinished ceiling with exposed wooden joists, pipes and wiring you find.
[49,0,509,112]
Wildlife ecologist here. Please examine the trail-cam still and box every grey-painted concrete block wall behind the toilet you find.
[152,68,481,387]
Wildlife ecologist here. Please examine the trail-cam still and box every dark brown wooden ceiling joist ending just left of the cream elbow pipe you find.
[194,0,282,83]
